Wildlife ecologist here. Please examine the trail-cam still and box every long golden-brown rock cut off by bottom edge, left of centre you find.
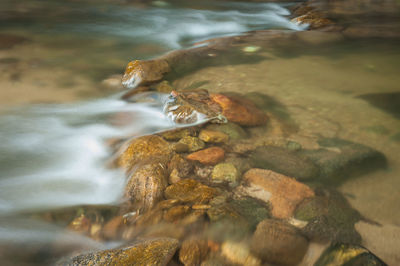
[57,238,179,266]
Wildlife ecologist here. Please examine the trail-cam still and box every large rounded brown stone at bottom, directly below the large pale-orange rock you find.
[251,219,308,265]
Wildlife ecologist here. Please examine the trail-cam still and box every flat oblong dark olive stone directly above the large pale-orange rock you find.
[251,146,319,180]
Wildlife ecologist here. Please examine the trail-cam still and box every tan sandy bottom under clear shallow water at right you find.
[173,37,400,265]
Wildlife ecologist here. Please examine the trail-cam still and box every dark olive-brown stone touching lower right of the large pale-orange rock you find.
[294,189,362,244]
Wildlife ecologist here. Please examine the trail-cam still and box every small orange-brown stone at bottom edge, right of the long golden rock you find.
[179,239,208,266]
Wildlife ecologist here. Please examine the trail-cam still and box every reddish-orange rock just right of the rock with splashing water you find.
[210,94,267,126]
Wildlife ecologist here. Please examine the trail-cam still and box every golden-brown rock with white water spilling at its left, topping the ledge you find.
[122,59,170,89]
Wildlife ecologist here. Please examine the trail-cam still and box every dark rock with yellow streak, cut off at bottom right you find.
[314,244,386,266]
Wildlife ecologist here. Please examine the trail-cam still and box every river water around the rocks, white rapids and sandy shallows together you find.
[0,0,400,265]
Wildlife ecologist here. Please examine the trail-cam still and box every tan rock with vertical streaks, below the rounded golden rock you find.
[125,162,168,211]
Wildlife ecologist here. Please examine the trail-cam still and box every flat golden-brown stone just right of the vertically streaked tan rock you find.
[164,179,217,204]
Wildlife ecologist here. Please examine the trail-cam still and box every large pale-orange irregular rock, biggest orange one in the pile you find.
[239,168,314,219]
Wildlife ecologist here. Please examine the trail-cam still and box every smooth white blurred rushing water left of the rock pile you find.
[0,91,205,214]
